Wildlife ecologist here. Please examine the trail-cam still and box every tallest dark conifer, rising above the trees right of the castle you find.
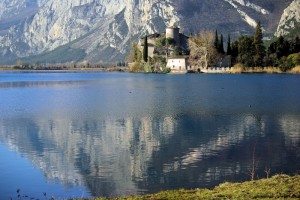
[253,22,266,67]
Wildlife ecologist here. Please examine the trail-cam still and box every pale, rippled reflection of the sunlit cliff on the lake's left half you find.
[0,117,175,196]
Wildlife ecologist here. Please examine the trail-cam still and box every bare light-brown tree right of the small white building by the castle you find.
[188,31,218,67]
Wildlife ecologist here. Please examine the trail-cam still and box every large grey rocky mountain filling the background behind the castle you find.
[0,0,292,63]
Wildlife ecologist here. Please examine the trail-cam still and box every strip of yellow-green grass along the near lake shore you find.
[81,175,300,200]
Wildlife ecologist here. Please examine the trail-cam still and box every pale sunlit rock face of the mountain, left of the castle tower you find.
[0,0,178,62]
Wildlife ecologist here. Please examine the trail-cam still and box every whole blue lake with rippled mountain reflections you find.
[0,71,300,199]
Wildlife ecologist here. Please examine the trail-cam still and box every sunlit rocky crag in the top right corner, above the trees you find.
[275,0,300,37]
